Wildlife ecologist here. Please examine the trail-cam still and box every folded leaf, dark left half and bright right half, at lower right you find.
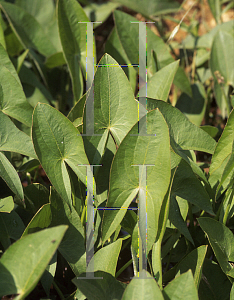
[176,245,207,289]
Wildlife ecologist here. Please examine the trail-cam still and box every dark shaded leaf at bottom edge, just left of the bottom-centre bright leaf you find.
[72,271,125,300]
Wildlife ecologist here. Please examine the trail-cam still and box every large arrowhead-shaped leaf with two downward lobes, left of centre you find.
[32,103,91,206]
